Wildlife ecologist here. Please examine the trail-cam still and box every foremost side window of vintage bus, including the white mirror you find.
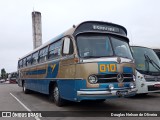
[62,37,74,55]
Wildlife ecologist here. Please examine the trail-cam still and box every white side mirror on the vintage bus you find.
[63,37,71,55]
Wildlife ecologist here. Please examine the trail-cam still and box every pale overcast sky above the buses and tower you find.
[0,0,160,73]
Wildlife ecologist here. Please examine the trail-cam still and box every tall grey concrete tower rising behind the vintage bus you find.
[32,11,42,49]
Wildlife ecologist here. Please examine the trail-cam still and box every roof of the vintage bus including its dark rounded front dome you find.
[20,21,127,59]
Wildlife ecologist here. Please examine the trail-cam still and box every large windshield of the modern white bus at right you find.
[132,47,160,73]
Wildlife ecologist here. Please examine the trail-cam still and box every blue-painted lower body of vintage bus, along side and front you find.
[26,79,132,101]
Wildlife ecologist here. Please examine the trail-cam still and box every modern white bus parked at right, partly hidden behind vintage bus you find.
[131,46,160,95]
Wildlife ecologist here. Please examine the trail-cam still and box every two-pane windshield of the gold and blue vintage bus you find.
[77,34,132,59]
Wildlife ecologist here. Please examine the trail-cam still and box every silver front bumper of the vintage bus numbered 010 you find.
[77,88,137,97]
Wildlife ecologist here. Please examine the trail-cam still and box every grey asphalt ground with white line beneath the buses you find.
[0,83,160,120]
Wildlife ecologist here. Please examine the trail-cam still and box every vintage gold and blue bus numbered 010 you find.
[18,21,137,106]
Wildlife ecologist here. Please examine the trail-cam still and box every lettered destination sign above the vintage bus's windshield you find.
[93,25,119,33]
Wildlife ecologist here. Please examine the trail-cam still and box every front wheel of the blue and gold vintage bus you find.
[50,84,66,107]
